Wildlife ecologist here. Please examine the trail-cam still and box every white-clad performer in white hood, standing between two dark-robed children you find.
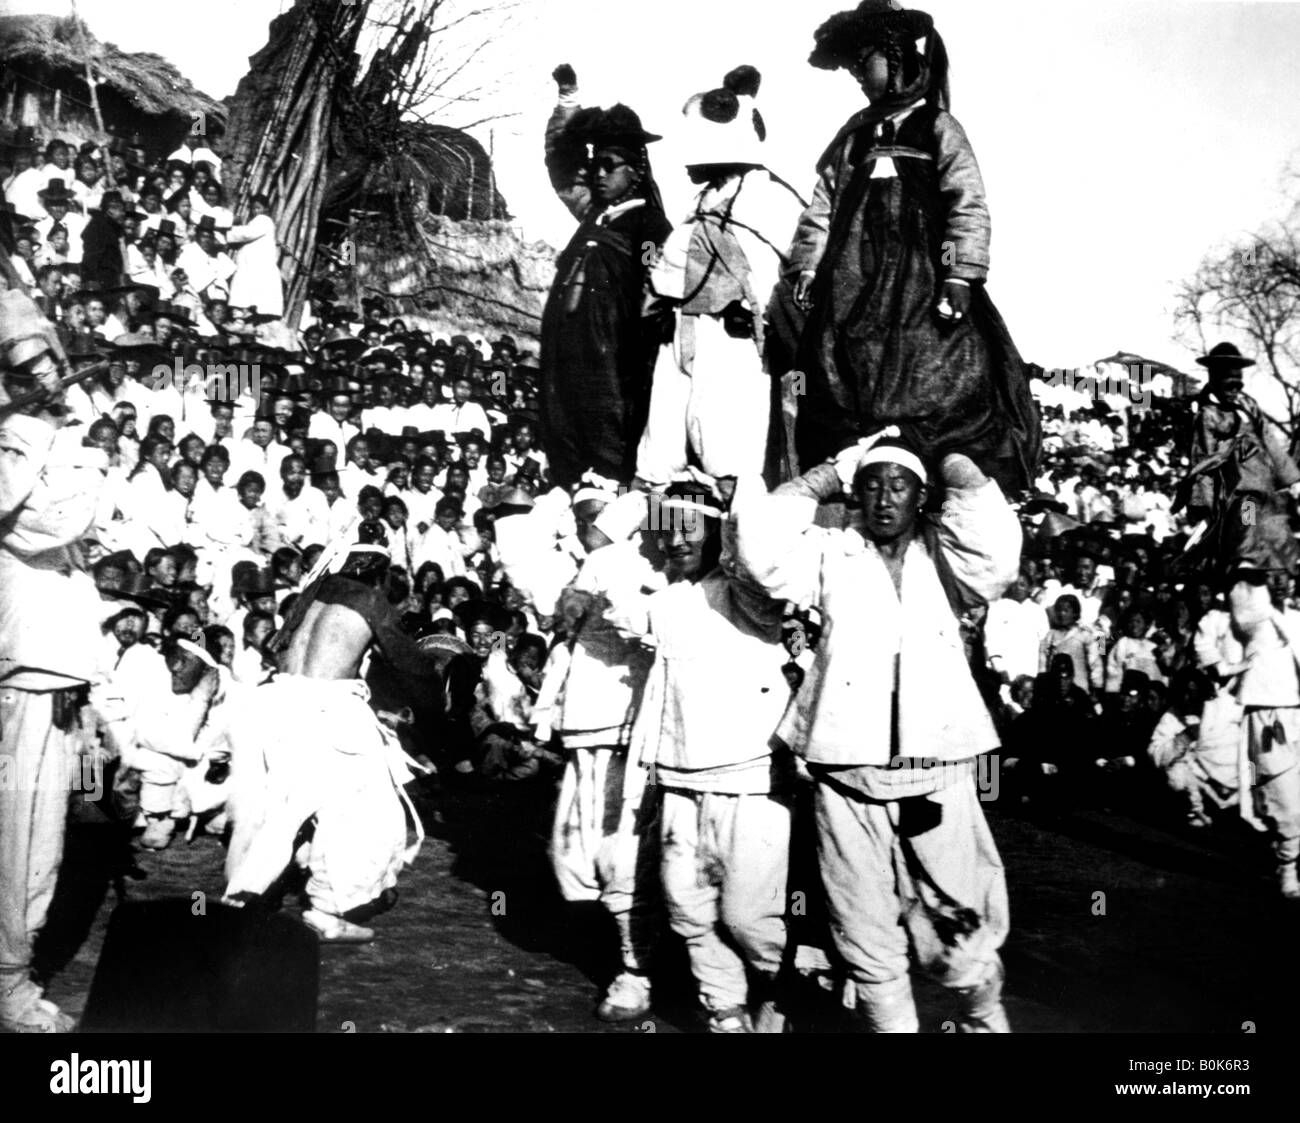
[637,66,805,495]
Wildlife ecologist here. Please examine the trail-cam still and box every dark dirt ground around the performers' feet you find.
[38,777,1300,1033]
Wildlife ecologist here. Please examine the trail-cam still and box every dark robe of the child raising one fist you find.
[540,204,671,487]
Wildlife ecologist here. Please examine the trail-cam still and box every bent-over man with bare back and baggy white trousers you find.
[226,530,441,942]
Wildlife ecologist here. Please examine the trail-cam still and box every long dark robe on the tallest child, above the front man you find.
[796,105,1041,493]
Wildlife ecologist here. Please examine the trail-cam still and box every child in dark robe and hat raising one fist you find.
[540,68,670,487]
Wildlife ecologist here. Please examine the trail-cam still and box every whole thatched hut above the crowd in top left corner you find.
[0,16,226,152]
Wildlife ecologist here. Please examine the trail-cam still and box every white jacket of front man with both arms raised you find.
[732,470,1021,766]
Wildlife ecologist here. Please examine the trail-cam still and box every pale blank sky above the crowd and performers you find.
[10,0,1300,369]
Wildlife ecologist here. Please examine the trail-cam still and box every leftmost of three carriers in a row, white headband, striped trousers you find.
[495,474,663,1022]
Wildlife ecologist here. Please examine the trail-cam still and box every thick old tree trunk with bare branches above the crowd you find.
[229,0,519,324]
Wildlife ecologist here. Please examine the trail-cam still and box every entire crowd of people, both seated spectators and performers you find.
[0,0,1300,1032]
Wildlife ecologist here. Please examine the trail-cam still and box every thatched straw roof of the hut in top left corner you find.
[0,16,226,123]
